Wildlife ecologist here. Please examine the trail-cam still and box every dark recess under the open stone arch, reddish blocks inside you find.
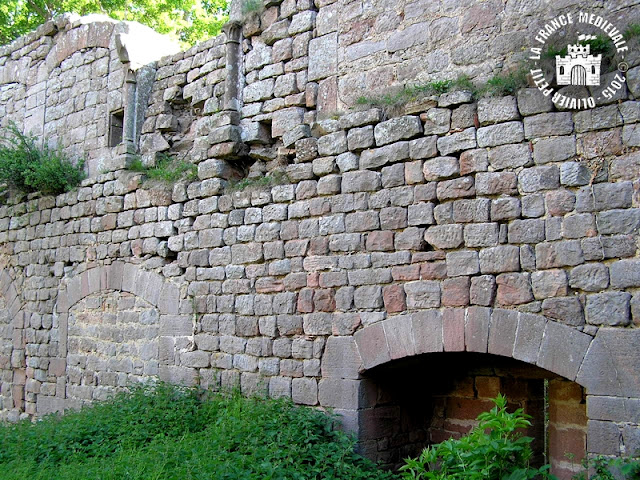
[359,352,587,480]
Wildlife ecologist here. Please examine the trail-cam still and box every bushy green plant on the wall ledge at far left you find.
[0,124,85,195]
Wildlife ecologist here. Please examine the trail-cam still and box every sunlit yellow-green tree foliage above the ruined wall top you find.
[0,0,228,46]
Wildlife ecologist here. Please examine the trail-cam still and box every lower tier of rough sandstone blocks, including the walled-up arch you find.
[0,87,640,462]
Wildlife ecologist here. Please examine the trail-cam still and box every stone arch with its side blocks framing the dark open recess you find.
[318,307,640,468]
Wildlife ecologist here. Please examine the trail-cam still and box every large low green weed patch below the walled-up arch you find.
[0,384,394,480]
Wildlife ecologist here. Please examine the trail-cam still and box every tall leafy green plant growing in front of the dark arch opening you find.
[400,394,551,480]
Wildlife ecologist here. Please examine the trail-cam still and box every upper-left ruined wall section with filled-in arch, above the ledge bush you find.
[0,16,176,176]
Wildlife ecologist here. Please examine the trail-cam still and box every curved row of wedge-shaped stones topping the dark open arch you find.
[355,307,593,386]
